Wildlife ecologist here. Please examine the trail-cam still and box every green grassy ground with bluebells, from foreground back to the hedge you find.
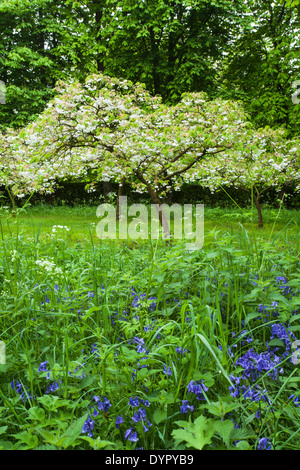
[0,205,300,450]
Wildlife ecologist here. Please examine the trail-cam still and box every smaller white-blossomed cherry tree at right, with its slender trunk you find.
[191,128,300,227]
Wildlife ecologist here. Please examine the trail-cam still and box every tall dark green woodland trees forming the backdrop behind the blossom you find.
[0,0,300,134]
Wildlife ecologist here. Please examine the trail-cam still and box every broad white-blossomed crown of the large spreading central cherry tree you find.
[14,75,296,229]
